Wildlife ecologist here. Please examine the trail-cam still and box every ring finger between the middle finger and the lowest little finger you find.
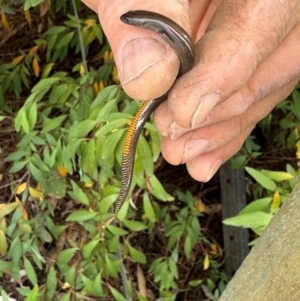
[161,81,297,165]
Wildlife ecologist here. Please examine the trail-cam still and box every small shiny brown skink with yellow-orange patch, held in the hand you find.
[115,10,195,214]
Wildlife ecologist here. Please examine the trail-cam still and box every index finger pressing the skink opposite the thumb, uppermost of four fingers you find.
[168,0,300,128]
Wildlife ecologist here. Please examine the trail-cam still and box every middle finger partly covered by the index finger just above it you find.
[155,24,300,139]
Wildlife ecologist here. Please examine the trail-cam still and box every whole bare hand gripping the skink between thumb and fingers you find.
[83,0,300,182]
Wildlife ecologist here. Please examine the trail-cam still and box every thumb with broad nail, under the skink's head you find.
[97,0,189,100]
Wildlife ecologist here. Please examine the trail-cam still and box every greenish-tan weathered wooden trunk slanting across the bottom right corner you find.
[219,181,300,301]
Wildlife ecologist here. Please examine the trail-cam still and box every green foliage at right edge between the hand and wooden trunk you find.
[223,84,300,239]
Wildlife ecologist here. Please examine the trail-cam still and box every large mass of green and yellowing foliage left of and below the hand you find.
[0,0,225,301]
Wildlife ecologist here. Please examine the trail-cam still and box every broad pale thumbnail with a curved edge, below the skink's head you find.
[121,38,167,84]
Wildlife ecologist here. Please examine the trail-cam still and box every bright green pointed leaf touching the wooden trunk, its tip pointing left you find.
[223,211,273,228]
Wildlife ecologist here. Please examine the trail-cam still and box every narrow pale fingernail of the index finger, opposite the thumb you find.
[190,93,221,129]
